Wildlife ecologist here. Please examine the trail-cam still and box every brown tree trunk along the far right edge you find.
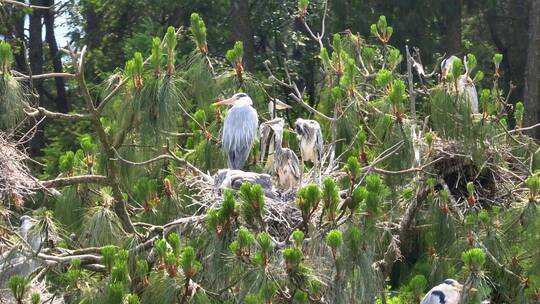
[524,1,540,139]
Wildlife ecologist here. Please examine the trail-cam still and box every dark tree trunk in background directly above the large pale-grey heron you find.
[231,0,255,72]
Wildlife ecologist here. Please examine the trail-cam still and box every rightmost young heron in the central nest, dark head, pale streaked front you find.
[295,118,323,164]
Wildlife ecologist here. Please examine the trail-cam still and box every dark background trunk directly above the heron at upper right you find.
[443,0,463,56]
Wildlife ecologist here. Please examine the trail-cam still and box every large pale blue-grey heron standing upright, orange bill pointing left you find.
[213,93,259,170]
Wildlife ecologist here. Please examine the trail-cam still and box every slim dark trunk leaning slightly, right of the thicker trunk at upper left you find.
[44,0,69,113]
